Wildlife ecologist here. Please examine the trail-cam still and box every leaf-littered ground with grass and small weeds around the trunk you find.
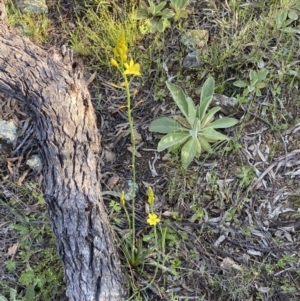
[0,0,300,301]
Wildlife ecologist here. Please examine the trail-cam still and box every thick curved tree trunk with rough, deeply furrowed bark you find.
[0,0,126,301]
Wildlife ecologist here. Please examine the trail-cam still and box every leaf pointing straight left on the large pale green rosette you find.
[149,117,188,134]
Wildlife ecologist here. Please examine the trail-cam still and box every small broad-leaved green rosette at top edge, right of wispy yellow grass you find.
[137,0,175,33]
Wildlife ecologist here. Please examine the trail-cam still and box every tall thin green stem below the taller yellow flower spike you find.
[123,74,136,258]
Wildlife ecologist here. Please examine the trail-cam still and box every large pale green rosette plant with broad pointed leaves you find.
[149,77,238,168]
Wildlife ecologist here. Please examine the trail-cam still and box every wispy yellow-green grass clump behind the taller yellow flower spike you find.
[70,0,141,66]
